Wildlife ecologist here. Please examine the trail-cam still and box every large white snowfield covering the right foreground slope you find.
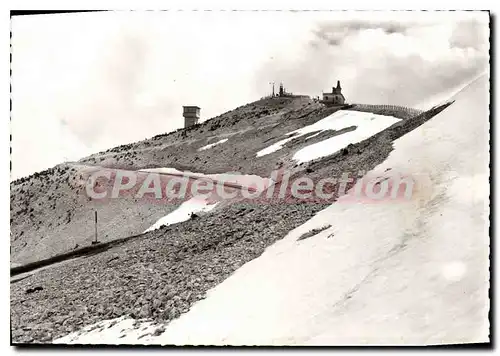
[151,77,489,345]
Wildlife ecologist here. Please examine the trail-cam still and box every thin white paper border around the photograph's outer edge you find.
[0,0,499,355]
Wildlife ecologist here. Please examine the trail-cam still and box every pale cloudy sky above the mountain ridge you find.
[11,11,489,179]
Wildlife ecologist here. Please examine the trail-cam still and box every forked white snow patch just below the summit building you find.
[257,110,399,163]
